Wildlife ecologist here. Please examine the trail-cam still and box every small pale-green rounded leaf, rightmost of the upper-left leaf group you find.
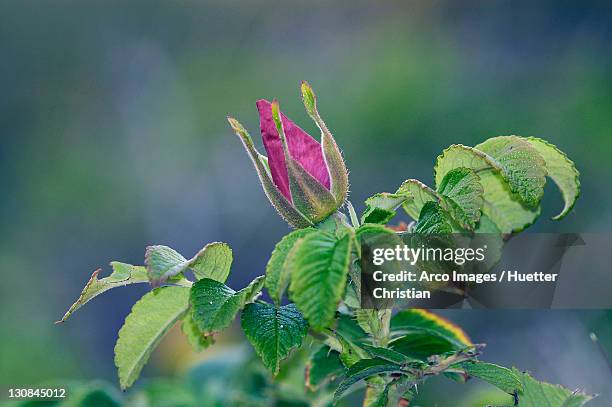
[189,242,233,283]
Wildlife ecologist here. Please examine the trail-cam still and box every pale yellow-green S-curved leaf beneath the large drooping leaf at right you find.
[435,144,540,233]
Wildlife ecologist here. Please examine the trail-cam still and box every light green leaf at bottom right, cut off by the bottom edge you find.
[512,368,593,407]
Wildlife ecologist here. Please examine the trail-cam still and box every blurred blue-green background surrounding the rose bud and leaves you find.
[0,0,612,406]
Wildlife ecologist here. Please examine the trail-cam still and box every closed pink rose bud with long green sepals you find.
[228,82,348,228]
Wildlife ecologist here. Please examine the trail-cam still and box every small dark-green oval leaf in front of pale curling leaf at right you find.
[438,167,484,230]
